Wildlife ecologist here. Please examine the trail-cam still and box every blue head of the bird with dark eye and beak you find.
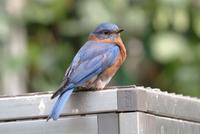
[90,23,124,40]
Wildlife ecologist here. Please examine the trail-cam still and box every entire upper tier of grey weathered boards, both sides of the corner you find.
[0,86,200,122]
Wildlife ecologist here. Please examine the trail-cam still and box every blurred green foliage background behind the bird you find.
[0,0,200,97]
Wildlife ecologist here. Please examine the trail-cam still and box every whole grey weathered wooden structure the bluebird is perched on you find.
[0,86,200,134]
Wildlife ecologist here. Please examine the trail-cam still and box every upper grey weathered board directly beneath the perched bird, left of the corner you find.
[0,90,117,120]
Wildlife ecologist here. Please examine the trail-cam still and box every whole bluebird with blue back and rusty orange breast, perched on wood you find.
[47,23,126,121]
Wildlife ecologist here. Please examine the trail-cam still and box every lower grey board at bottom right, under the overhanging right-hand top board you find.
[119,112,200,134]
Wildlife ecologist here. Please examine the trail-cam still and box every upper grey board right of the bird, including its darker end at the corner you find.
[118,87,200,122]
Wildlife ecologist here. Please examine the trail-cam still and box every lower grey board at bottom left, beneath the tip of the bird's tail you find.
[0,115,98,134]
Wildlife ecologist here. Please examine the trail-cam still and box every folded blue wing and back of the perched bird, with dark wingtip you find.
[52,41,120,98]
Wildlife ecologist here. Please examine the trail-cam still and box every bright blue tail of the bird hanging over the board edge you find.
[47,88,74,121]
